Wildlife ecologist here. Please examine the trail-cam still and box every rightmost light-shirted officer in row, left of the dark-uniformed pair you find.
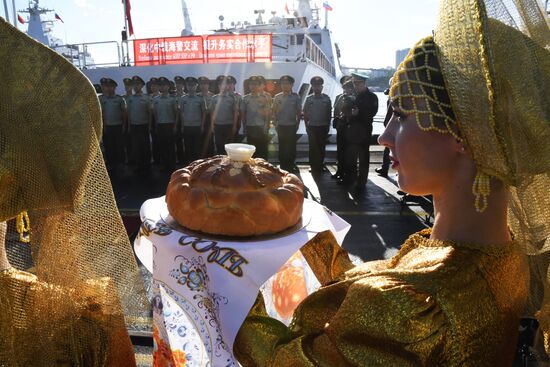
[304,76,332,174]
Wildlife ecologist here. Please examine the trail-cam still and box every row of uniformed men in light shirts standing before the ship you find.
[100,75,332,173]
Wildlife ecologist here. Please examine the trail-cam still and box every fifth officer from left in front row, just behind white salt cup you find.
[209,75,240,154]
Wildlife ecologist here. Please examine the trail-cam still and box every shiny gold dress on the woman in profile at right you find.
[234,230,528,367]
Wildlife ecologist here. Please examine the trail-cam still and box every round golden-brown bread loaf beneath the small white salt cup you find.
[166,155,304,236]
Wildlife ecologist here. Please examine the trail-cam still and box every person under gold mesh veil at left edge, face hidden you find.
[0,19,148,367]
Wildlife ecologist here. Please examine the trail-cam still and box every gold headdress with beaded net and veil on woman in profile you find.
[390,0,550,350]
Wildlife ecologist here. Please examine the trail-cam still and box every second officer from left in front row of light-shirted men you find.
[126,75,152,173]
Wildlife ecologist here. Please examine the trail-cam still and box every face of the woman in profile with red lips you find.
[378,100,464,195]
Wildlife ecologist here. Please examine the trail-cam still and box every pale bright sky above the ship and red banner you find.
[0,0,438,68]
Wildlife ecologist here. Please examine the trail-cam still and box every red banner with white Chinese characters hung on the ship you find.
[134,34,272,66]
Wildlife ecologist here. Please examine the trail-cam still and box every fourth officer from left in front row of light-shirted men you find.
[179,76,206,163]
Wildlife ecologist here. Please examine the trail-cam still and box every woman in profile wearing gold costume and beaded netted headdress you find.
[234,0,550,366]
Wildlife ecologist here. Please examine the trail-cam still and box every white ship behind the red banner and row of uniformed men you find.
[68,0,341,100]
